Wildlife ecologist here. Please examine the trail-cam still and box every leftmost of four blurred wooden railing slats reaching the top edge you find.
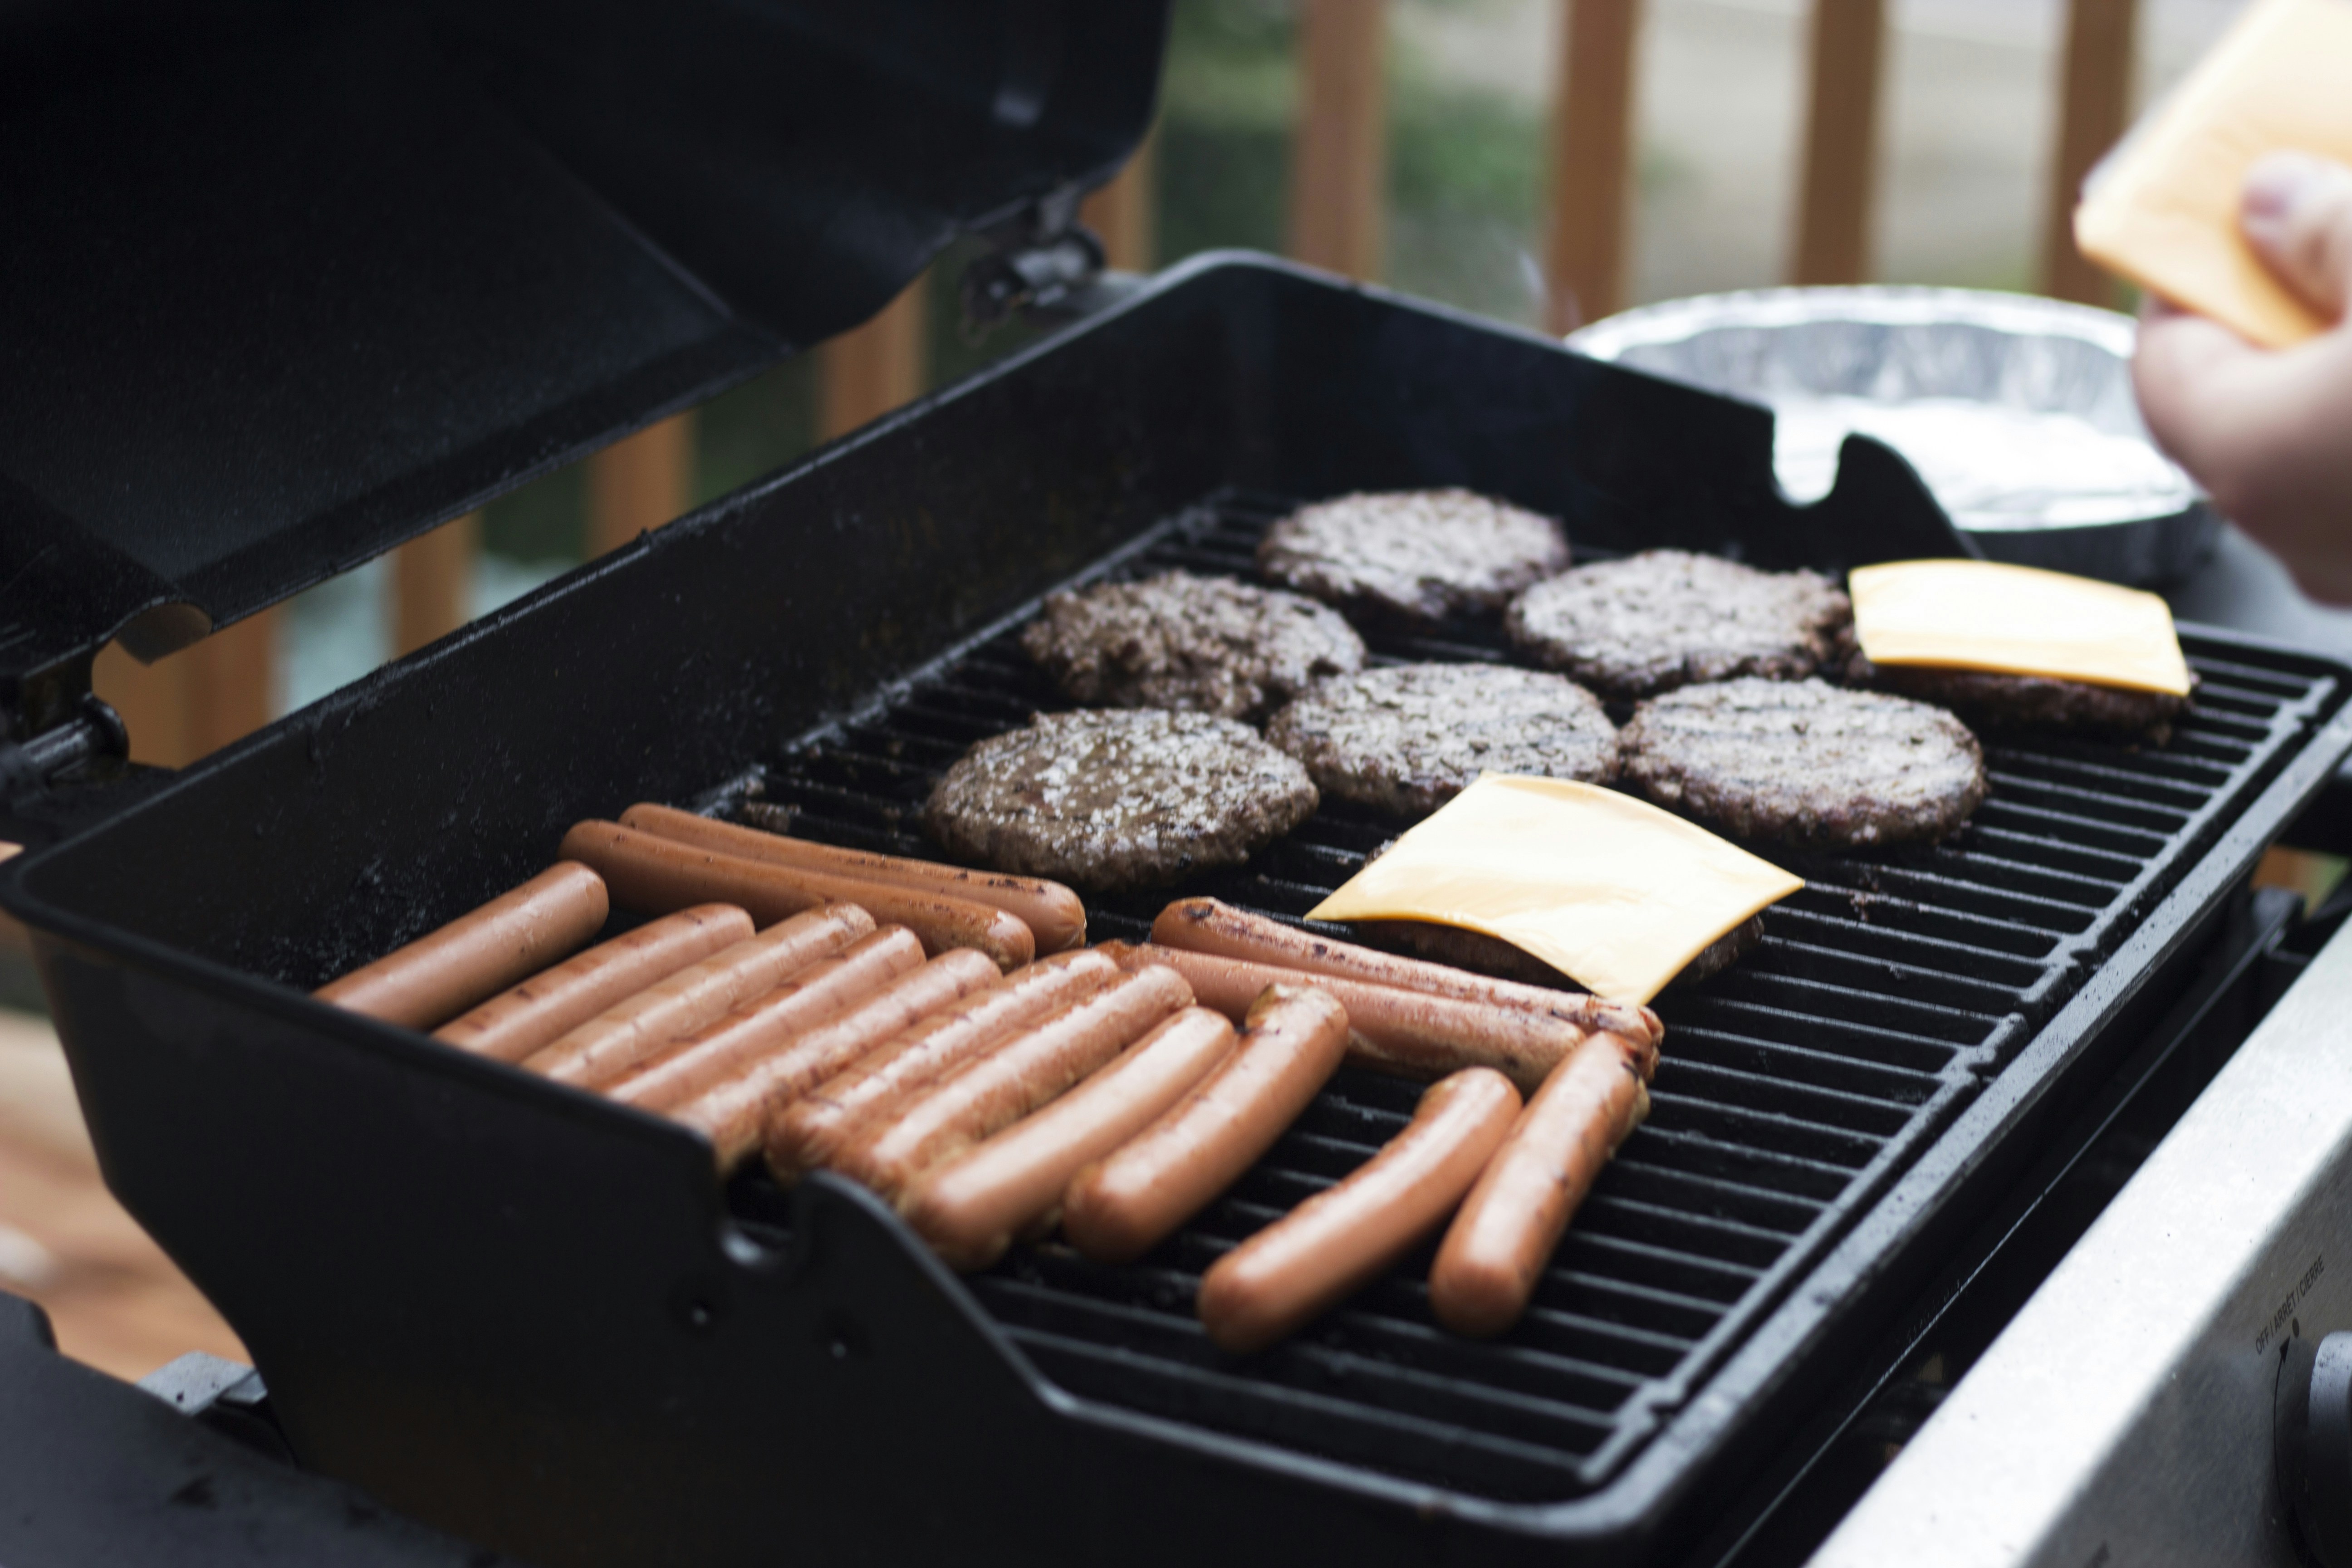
[1287,0,1388,280]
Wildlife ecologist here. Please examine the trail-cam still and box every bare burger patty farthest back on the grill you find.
[1258,489,1569,625]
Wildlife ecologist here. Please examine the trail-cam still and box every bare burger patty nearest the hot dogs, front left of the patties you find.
[922,708,1315,889]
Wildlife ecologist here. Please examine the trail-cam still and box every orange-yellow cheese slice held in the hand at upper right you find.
[2074,0,2352,348]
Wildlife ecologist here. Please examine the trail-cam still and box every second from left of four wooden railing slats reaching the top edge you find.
[1543,0,1642,332]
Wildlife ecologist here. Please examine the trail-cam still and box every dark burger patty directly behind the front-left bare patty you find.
[1021,571,1364,722]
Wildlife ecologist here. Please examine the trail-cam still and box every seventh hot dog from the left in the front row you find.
[830,969,1192,1201]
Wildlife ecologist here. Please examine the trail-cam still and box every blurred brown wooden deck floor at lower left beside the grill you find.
[0,1011,250,1377]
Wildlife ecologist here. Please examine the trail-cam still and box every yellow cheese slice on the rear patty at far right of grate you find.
[1846,562,2190,696]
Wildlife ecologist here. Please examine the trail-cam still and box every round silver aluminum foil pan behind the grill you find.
[1569,287,2220,588]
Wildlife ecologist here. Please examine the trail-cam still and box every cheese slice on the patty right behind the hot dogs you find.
[1308,774,1804,1001]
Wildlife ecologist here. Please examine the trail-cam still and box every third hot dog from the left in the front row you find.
[522,903,875,1088]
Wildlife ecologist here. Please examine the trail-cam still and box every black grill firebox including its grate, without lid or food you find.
[14,259,2352,1568]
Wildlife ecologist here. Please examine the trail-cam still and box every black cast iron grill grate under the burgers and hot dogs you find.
[736,491,2331,1500]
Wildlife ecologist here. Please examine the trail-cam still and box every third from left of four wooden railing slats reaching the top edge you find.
[1790,0,1886,284]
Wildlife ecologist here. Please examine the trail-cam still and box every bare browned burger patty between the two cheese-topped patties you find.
[1623,679,1985,848]
